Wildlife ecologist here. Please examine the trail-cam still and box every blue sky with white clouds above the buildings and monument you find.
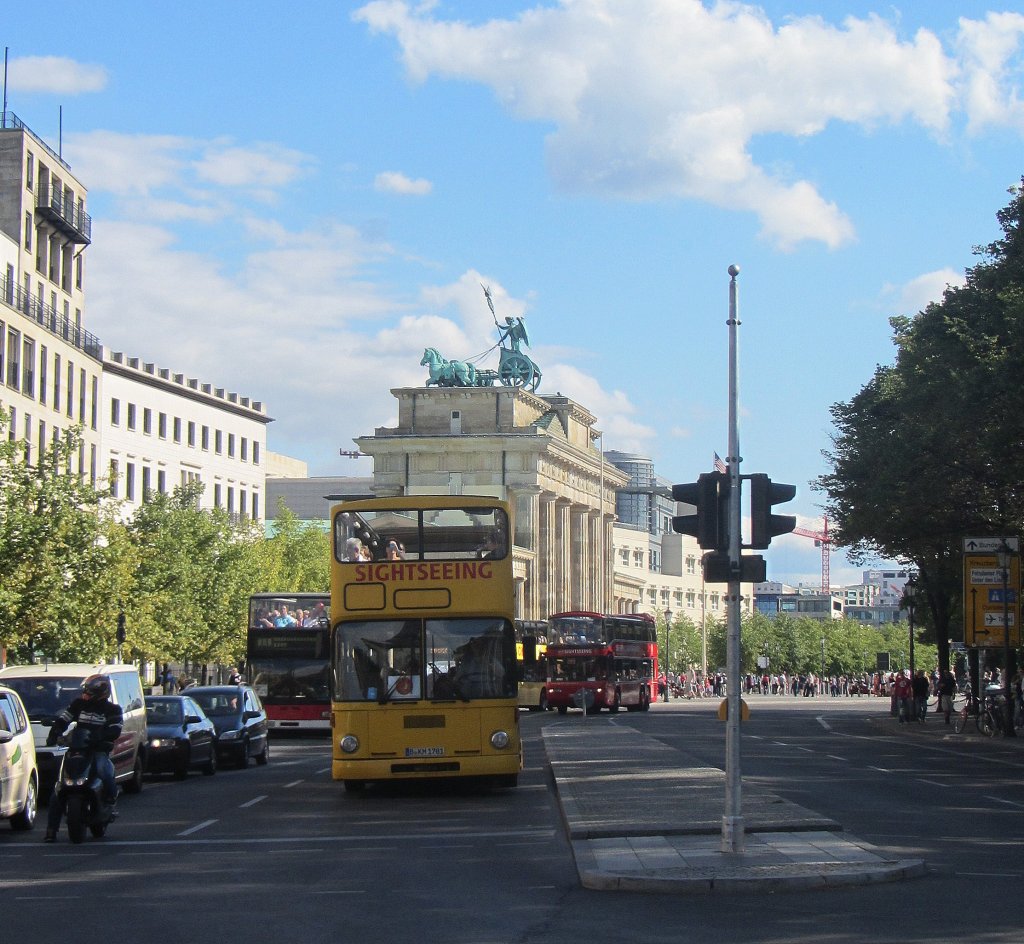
[0,0,1024,583]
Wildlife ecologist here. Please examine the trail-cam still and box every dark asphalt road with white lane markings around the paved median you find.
[6,696,1024,944]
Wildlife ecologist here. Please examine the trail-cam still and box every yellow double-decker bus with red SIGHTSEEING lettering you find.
[331,496,522,790]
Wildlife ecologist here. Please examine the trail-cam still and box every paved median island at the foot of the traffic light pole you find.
[543,721,925,894]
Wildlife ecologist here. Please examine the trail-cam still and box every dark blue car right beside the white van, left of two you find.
[145,695,217,779]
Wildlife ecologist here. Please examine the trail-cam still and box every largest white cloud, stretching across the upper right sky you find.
[353,0,1024,248]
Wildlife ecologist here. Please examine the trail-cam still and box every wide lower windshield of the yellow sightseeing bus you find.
[335,617,516,701]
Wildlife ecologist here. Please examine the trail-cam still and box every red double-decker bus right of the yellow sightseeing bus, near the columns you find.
[547,612,657,714]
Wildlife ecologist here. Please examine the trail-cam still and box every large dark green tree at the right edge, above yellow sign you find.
[814,181,1024,668]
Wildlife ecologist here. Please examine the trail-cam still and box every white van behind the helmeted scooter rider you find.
[0,662,147,800]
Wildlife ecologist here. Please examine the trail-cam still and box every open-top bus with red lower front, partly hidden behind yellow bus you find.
[246,593,331,733]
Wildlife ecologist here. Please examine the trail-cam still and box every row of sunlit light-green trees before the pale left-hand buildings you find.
[0,411,330,664]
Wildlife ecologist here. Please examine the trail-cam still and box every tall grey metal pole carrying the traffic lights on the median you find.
[722,265,743,853]
